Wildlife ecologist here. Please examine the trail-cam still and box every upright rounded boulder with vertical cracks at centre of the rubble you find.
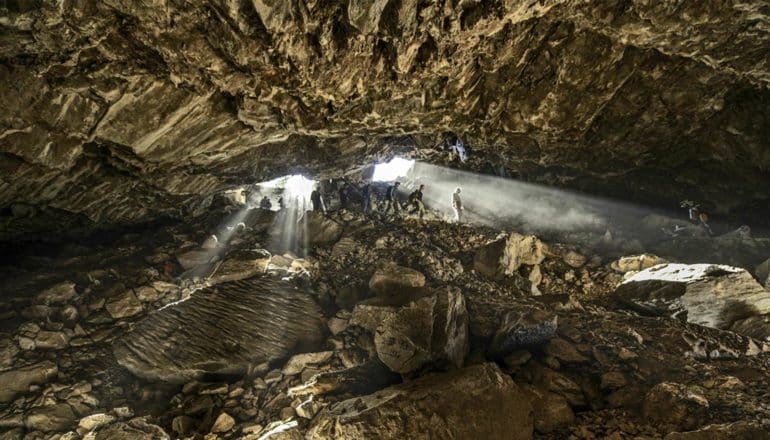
[374,289,469,374]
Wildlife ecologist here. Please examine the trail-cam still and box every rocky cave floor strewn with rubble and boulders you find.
[0,196,770,440]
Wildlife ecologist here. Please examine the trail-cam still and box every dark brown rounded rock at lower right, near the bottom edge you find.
[642,382,709,432]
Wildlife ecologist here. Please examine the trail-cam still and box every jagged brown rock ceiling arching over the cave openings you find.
[0,0,770,225]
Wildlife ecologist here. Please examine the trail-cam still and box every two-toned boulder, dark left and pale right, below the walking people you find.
[473,232,548,279]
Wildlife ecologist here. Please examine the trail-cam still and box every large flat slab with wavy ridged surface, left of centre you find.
[114,278,326,383]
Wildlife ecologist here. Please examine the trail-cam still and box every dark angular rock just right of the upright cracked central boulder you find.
[489,307,558,357]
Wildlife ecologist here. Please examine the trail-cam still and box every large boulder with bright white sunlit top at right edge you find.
[613,264,770,329]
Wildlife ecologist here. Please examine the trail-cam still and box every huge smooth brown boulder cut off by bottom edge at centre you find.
[306,363,533,440]
